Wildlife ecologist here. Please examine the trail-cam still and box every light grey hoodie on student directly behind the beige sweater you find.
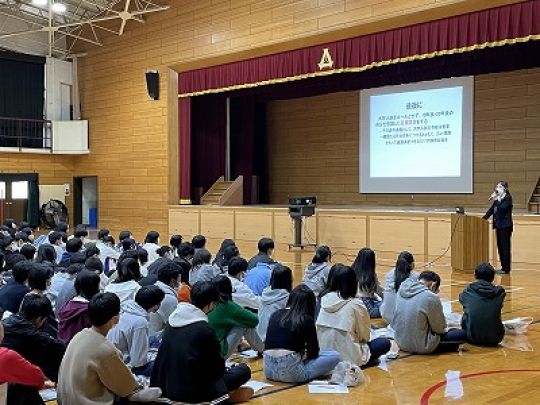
[107,300,148,368]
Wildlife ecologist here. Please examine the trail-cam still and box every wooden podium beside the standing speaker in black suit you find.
[450,214,489,274]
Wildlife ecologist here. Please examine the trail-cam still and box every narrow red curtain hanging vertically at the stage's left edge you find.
[178,98,191,204]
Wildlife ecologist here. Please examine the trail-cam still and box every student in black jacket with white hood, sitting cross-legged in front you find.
[150,281,253,403]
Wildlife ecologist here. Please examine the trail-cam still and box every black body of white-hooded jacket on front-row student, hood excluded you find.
[150,310,228,403]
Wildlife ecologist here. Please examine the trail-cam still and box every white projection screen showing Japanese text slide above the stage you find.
[360,78,473,193]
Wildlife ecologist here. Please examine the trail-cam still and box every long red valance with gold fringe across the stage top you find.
[179,0,540,97]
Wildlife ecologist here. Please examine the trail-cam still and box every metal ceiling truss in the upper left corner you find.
[0,0,169,59]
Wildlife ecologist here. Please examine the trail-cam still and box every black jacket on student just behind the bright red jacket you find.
[2,315,66,382]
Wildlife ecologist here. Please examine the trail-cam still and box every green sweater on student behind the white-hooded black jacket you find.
[208,301,259,356]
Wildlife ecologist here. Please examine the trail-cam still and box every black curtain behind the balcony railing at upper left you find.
[0,52,45,148]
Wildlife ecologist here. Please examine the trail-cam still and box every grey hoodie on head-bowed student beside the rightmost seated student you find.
[392,277,446,354]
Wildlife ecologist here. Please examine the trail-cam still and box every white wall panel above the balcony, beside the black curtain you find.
[45,57,73,121]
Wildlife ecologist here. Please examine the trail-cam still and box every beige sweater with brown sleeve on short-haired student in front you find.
[57,328,140,405]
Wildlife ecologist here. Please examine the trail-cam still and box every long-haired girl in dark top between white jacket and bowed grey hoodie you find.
[352,248,383,318]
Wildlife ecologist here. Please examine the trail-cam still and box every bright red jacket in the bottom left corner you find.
[0,347,45,389]
